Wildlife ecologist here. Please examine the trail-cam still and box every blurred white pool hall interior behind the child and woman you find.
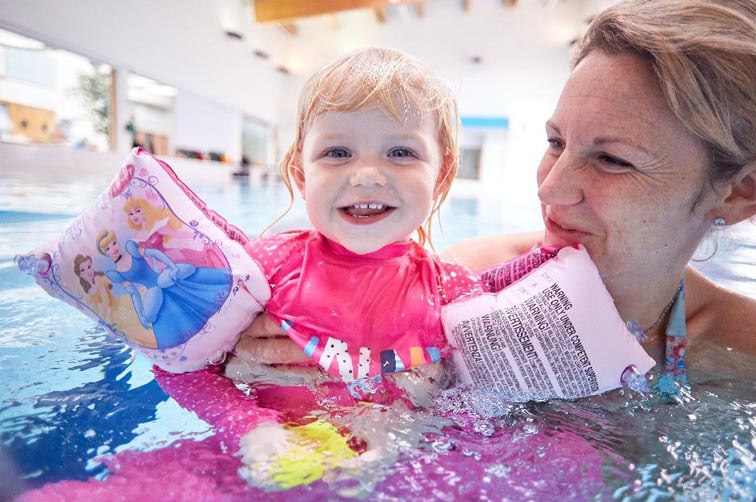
[0,0,613,214]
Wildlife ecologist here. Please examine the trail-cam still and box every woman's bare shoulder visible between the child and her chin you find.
[441,231,543,272]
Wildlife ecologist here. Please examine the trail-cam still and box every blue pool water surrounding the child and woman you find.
[0,168,756,500]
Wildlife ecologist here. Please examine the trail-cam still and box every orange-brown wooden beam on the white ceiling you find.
[253,0,424,23]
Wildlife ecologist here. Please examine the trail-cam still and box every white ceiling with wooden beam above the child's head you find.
[0,0,613,123]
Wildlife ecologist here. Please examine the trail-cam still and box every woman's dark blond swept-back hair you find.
[572,0,756,187]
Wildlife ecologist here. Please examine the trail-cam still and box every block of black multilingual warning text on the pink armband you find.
[452,283,598,397]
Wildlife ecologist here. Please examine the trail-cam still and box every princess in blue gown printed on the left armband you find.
[97,230,233,350]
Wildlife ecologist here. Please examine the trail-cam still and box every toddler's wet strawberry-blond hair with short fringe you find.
[274,47,459,245]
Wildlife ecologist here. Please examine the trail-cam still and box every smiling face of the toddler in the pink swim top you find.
[292,106,442,254]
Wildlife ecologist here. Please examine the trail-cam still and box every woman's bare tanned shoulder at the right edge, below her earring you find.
[685,267,756,356]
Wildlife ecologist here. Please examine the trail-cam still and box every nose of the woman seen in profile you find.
[537,151,586,206]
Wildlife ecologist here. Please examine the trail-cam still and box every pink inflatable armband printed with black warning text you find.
[441,247,654,401]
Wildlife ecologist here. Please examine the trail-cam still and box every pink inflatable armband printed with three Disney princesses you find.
[16,148,270,373]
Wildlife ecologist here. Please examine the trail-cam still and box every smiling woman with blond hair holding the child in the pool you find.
[230,0,756,382]
